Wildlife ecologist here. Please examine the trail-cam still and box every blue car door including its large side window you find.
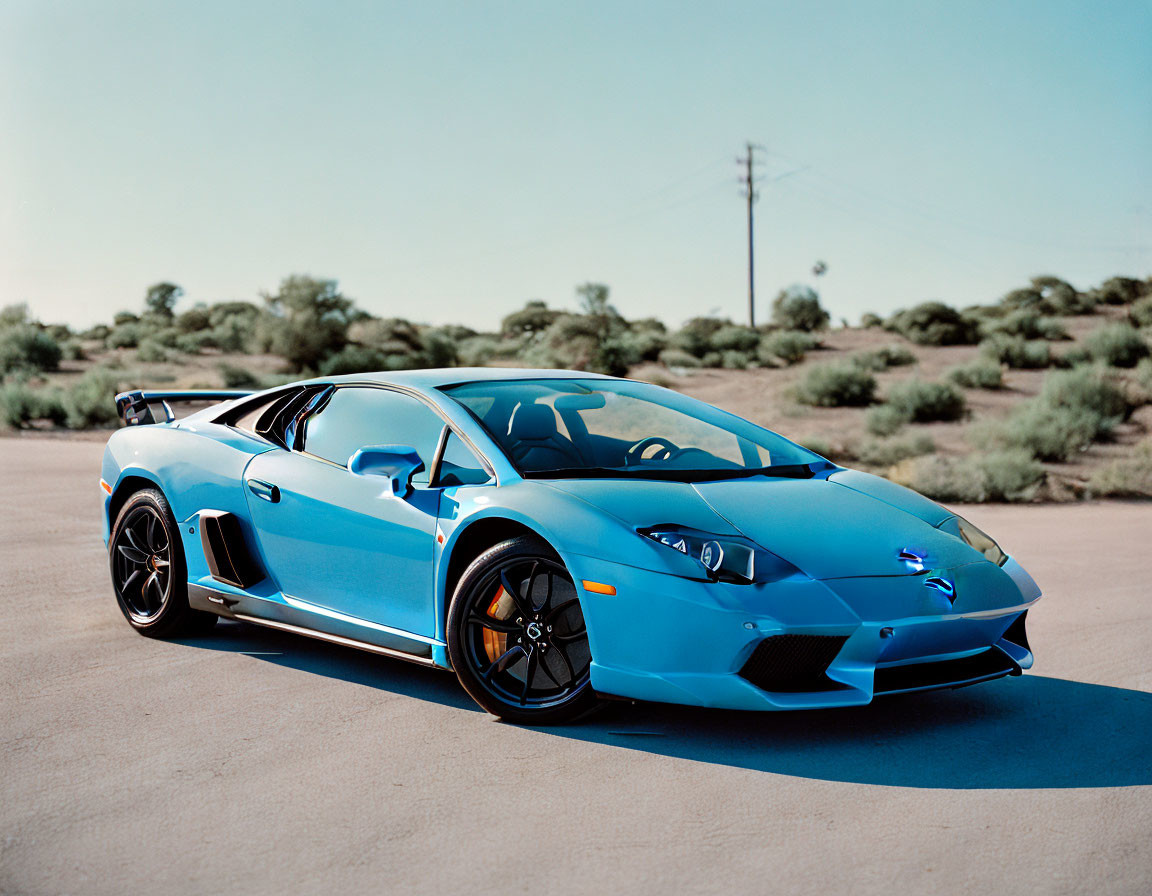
[244,386,445,637]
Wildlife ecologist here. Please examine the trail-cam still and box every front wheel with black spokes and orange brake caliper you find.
[448,536,600,724]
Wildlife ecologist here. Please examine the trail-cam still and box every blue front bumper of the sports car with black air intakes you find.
[566,548,1039,709]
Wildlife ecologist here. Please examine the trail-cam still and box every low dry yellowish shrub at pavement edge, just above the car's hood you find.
[887,450,1044,502]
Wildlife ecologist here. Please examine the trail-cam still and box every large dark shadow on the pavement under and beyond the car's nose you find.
[547,675,1152,789]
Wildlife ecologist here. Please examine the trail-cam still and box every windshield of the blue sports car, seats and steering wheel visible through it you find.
[442,379,821,481]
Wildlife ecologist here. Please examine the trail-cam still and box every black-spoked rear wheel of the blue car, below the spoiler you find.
[108,488,218,638]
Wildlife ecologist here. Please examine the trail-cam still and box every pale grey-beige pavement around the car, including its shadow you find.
[0,438,1152,896]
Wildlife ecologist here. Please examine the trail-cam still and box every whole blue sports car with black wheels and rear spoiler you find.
[100,369,1040,724]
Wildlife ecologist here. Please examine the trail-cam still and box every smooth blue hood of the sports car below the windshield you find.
[539,474,980,579]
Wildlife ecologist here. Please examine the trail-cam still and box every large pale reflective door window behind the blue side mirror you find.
[304,387,445,483]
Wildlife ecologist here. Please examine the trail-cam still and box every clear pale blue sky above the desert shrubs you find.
[0,0,1152,326]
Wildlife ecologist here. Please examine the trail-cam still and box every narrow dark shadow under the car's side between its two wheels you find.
[179,620,484,713]
